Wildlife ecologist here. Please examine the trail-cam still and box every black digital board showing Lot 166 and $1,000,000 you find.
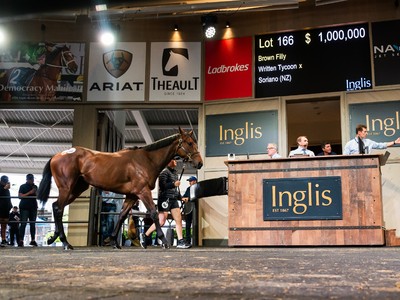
[255,23,372,98]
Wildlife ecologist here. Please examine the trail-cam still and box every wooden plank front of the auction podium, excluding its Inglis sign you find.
[226,155,384,246]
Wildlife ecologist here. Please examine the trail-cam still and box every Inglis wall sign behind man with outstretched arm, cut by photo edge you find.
[349,101,400,142]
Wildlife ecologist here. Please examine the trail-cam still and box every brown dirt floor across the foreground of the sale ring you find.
[0,247,400,299]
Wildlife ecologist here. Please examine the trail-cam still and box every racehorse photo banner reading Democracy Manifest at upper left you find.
[0,42,85,101]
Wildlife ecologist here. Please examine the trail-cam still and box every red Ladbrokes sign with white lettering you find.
[204,37,253,101]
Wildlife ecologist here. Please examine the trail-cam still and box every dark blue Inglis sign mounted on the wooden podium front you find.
[263,176,343,221]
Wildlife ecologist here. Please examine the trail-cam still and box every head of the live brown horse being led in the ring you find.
[176,127,203,169]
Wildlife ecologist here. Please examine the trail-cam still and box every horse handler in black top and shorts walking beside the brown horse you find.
[139,159,192,249]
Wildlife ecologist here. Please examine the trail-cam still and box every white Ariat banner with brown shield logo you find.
[87,43,146,101]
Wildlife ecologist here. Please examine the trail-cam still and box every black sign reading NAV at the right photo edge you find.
[372,20,400,86]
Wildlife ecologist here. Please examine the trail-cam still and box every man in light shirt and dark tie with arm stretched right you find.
[343,124,400,155]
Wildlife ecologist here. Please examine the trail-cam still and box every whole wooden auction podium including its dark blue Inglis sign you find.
[225,155,384,246]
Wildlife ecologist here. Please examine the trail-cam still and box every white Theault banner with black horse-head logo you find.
[149,42,201,101]
